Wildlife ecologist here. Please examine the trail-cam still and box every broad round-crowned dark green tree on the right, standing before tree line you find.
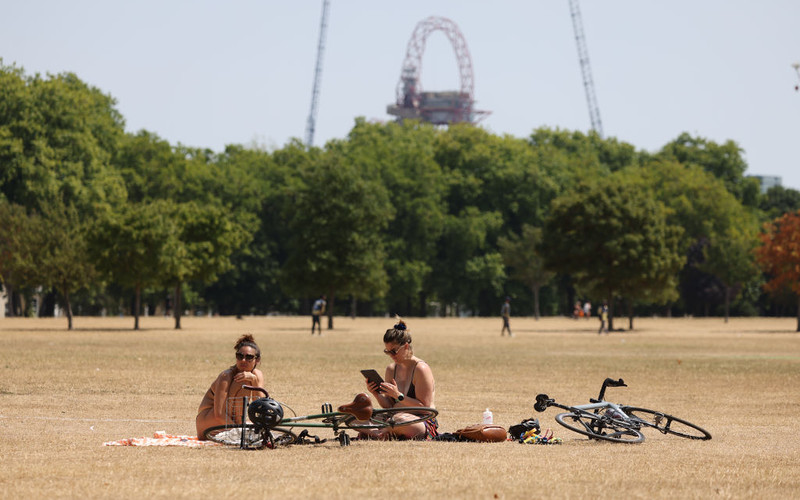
[540,175,684,328]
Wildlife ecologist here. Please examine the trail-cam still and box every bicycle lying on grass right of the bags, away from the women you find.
[533,378,711,443]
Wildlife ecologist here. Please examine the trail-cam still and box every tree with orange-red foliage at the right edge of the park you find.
[756,210,800,332]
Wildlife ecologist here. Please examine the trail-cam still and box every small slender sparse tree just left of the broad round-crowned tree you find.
[498,224,554,320]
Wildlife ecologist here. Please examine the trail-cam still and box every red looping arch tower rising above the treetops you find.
[387,16,489,125]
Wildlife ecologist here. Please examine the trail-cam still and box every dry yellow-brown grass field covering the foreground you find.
[0,317,800,499]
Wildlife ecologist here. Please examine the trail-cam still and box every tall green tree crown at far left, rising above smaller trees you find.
[0,61,125,215]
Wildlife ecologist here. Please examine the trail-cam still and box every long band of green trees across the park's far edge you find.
[0,61,800,328]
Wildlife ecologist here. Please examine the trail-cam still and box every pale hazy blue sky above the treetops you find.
[0,0,800,190]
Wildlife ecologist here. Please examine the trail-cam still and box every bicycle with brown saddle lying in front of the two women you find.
[200,386,438,449]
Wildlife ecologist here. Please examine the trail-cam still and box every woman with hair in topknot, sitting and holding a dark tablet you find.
[367,318,439,439]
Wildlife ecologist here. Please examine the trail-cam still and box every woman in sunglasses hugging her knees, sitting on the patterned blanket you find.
[195,334,264,439]
